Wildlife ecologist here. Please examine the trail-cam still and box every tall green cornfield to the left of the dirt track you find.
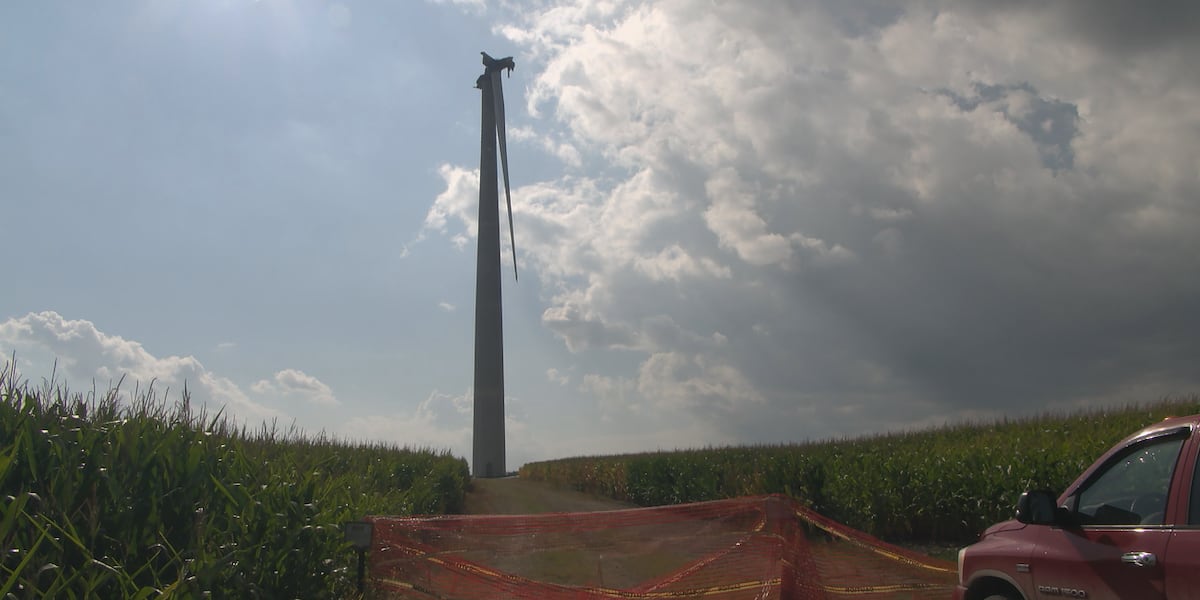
[0,366,469,599]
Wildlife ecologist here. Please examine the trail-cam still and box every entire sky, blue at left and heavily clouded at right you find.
[0,0,1200,469]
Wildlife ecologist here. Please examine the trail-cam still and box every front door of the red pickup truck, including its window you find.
[1030,431,1187,600]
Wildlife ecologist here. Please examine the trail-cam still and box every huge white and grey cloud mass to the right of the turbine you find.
[426,0,1200,439]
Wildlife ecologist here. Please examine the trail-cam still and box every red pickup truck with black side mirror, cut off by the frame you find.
[954,415,1200,600]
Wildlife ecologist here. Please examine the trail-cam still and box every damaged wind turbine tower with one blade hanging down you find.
[470,53,517,478]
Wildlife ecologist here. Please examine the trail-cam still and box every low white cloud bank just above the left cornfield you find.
[0,311,283,422]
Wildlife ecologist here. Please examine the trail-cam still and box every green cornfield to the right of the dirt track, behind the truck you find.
[520,396,1200,544]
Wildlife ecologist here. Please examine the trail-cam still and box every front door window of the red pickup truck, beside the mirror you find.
[1075,436,1183,526]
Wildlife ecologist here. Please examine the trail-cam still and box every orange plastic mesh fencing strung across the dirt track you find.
[368,496,955,600]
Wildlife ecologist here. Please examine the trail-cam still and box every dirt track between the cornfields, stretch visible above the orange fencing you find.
[466,476,634,515]
